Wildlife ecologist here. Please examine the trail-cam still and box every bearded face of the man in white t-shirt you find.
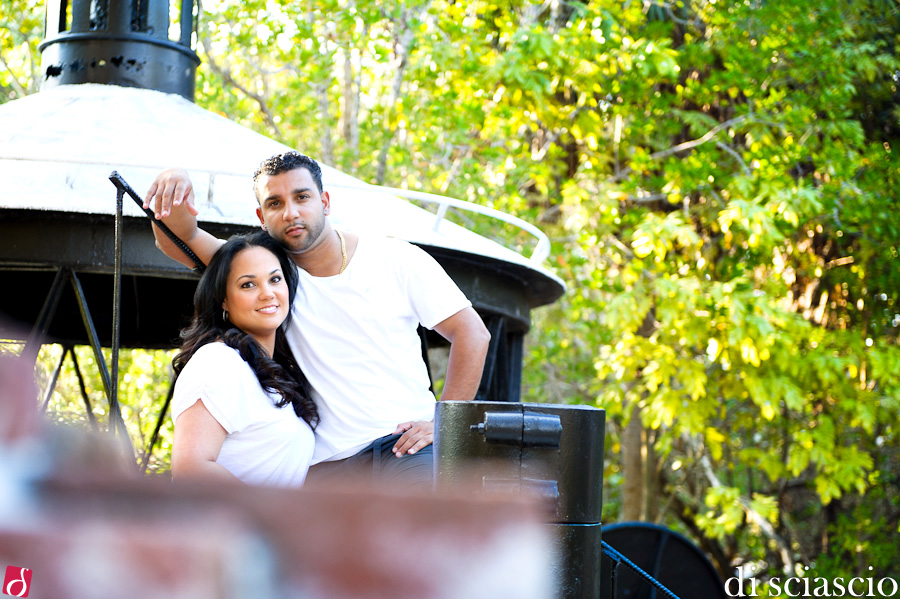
[256,168,330,254]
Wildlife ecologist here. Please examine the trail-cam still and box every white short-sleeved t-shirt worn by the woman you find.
[172,342,315,487]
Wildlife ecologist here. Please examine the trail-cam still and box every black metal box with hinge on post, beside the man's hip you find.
[434,402,606,599]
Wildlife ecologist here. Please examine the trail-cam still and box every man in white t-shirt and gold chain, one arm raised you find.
[144,152,490,485]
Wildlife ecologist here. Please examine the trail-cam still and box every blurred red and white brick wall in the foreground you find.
[0,356,554,599]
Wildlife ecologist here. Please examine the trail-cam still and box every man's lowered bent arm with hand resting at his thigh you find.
[393,307,491,457]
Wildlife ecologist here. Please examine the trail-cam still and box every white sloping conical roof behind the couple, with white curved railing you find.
[0,84,563,288]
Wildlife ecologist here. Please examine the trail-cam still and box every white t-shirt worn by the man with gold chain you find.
[287,236,472,464]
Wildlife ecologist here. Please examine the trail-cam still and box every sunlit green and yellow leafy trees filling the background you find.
[0,0,900,576]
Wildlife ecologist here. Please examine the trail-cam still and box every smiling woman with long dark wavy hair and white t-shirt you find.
[172,232,318,486]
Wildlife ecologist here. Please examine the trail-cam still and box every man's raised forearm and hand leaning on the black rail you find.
[144,168,224,268]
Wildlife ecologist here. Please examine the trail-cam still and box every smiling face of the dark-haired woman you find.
[222,247,290,345]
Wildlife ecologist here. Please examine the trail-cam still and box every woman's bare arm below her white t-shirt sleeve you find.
[172,399,240,482]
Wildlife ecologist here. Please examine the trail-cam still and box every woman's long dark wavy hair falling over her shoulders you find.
[172,231,319,428]
